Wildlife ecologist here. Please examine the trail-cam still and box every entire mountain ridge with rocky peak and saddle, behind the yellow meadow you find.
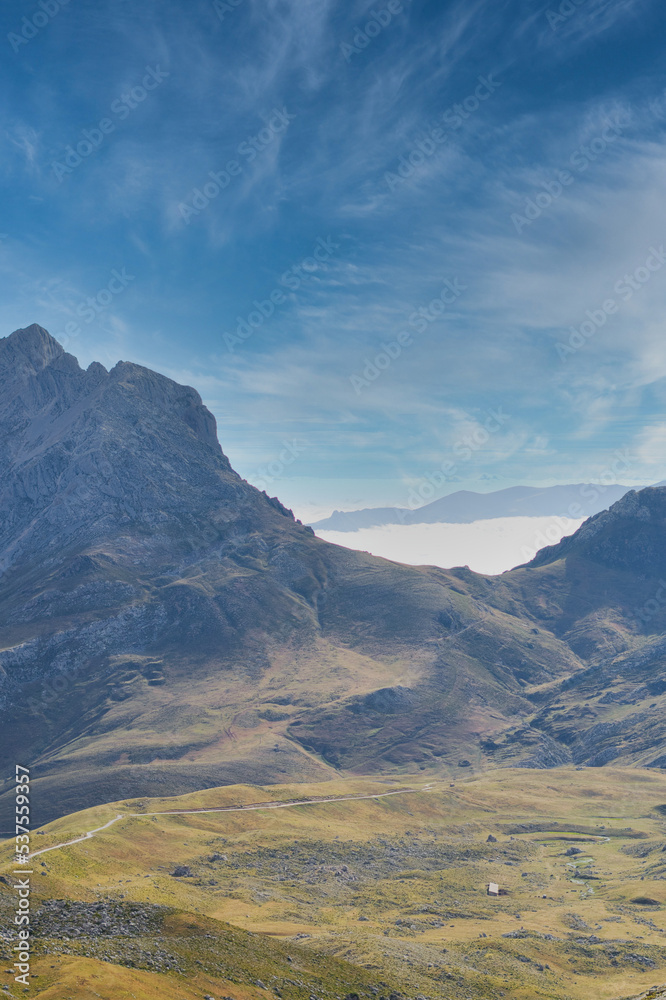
[0,327,666,820]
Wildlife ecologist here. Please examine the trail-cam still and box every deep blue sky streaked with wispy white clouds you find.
[0,0,666,516]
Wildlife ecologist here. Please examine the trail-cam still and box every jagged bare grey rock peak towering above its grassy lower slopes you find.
[0,324,296,569]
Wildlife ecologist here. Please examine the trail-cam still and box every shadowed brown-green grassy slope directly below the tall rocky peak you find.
[0,508,584,821]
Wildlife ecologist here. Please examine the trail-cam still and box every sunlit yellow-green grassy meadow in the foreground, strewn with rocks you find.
[1,768,666,1000]
